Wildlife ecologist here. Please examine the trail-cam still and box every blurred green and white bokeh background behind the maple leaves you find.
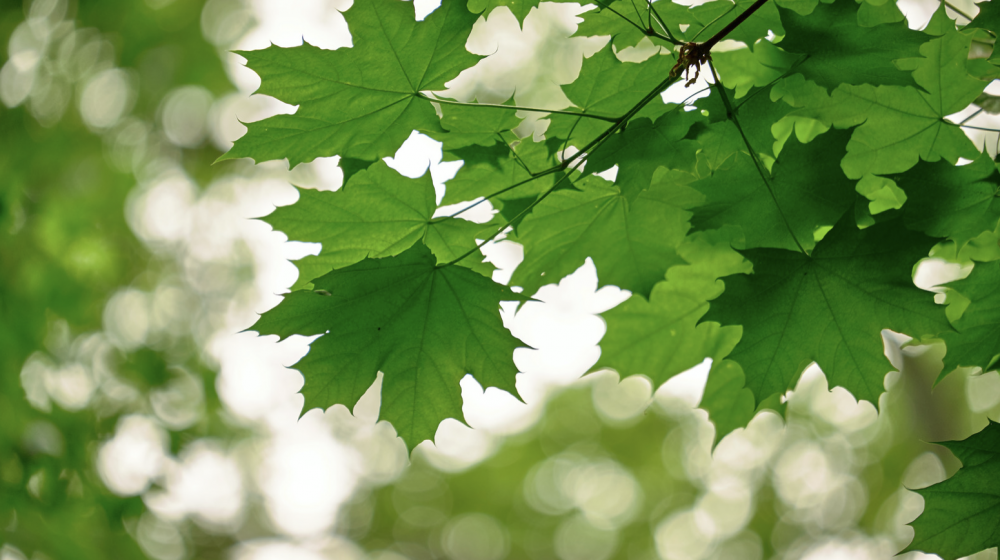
[0,0,1000,560]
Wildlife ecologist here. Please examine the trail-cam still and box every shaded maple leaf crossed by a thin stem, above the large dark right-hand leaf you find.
[691,131,857,251]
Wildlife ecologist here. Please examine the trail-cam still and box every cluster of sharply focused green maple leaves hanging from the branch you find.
[224,0,1000,557]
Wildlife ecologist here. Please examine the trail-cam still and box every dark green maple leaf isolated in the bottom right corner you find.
[903,421,1000,560]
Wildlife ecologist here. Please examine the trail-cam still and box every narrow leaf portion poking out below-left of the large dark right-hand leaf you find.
[698,360,755,443]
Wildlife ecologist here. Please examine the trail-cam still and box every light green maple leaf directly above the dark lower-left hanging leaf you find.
[264,161,493,288]
